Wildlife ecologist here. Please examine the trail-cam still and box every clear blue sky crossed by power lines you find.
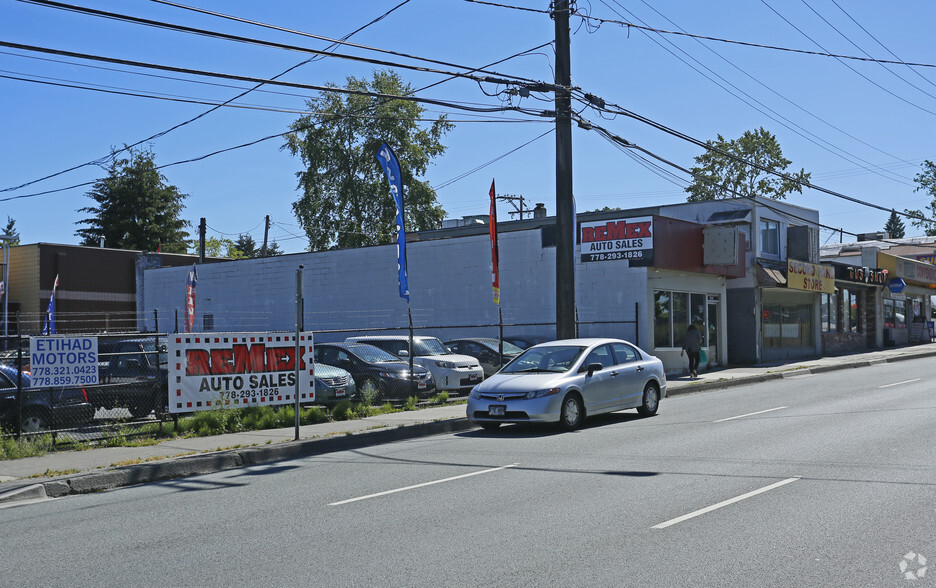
[0,0,936,252]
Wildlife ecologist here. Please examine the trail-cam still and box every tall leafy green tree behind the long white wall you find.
[283,70,453,251]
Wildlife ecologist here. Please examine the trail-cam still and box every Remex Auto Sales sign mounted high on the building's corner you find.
[580,216,653,267]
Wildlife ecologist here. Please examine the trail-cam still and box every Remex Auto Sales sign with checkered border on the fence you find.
[168,332,315,412]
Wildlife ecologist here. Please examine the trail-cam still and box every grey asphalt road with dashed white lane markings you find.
[0,359,936,587]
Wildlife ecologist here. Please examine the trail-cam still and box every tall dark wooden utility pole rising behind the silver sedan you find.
[552,0,575,339]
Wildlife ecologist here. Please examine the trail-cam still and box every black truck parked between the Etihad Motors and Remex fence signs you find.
[87,335,169,418]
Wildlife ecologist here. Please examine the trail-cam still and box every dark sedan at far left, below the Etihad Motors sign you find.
[0,365,94,433]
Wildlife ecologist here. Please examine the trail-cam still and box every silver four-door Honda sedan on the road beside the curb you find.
[467,339,666,431]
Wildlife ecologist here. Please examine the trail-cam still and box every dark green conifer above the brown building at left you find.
[75,149,190,253]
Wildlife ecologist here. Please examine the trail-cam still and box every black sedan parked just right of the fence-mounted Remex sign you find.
[315,343,435,404]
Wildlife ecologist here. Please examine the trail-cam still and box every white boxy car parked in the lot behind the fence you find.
[345,335,484,392]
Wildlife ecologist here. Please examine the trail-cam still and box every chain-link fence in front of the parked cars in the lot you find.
[0,305,640,441]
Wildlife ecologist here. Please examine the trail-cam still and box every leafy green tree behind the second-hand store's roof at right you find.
[686,127,810,202]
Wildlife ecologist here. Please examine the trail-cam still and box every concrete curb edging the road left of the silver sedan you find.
[0,418,475,504]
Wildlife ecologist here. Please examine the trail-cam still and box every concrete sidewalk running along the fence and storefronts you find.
[0,343,936,504]
